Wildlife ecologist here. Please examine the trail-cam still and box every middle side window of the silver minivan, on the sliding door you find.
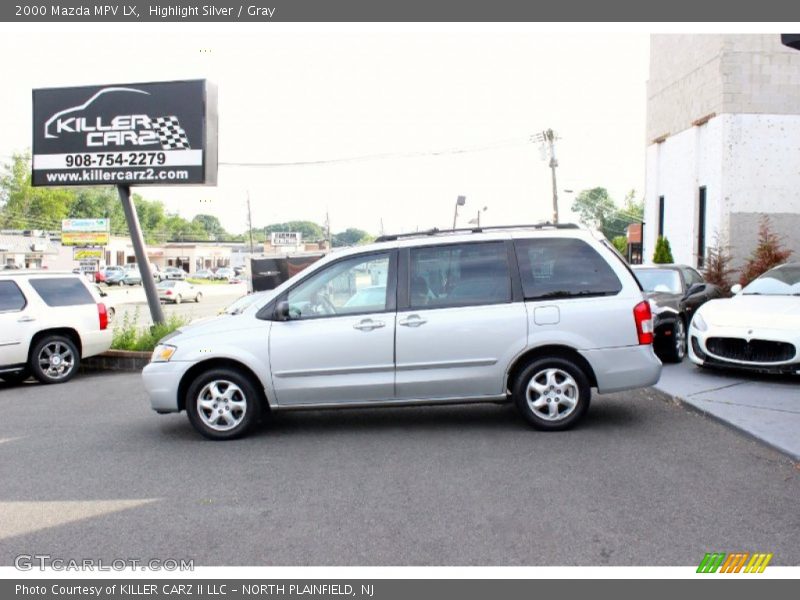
[409,242,511,309]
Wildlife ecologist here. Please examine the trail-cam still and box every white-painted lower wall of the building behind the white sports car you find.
[644,114,800,267]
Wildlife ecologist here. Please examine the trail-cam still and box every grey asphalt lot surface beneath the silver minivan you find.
[0,374,800,565]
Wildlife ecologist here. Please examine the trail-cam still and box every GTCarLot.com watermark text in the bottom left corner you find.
[14,554,194,571]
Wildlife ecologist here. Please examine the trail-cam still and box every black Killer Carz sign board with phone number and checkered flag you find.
[32,80,217,186]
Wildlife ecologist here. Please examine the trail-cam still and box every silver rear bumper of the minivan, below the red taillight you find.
[581,344,661,394]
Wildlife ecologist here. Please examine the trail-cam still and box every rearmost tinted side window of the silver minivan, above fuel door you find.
[514,238,622,300]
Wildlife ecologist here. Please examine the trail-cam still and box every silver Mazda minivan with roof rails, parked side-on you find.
[143,225,661,439]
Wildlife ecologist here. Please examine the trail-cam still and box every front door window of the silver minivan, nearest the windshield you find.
[286,253,389,319]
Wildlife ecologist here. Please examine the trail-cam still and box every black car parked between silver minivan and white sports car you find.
[632,265,723,362]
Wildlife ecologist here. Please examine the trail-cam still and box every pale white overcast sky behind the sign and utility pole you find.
[0,24,649,234]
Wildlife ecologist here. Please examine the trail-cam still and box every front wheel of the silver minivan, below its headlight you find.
[186,368,263,440]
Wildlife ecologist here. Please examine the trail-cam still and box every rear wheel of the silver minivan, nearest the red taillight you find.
[511,358,592,431]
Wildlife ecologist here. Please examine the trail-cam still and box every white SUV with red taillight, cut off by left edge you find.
[0,271,112,383]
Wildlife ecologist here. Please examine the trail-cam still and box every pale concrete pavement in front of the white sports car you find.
[655,359,800,460]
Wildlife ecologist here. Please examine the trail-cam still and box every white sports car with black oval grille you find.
[689,263,800,373]
